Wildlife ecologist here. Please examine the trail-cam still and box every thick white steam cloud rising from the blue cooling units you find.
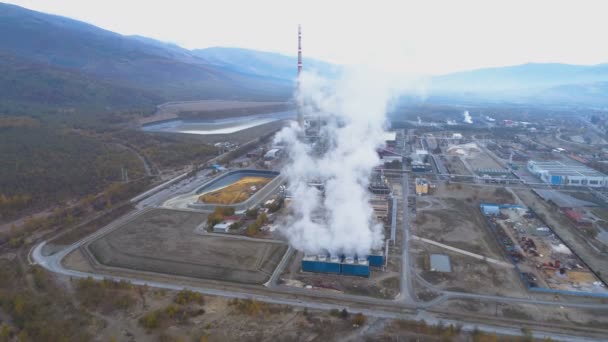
[275,70,391,256]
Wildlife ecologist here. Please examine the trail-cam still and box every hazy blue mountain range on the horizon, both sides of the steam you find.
[0,3,608,113]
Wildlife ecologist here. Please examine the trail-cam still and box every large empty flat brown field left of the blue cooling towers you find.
[81,209,287,284]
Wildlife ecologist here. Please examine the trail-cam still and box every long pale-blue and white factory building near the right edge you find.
[527,160,608,188]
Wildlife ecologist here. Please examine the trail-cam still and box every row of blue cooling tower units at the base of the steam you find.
[301,252,384,277]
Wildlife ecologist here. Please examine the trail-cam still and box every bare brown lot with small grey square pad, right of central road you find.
[410,184,523,296]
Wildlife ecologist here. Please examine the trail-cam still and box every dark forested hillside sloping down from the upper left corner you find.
[0,3,295,219]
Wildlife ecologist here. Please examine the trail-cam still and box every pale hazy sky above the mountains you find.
[8,0,608,73]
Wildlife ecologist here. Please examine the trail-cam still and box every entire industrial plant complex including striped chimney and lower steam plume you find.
[25,19,608,339]
